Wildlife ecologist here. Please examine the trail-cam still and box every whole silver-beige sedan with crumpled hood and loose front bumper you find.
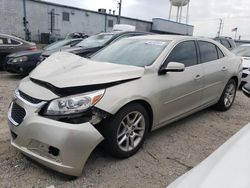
[8,35,242,176]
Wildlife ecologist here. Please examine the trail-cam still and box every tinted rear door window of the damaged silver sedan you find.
[198,41,218,63]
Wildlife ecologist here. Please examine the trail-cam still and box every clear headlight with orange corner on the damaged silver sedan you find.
[44,90,105,116]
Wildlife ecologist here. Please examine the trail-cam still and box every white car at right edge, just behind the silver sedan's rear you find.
[232,44,250,85]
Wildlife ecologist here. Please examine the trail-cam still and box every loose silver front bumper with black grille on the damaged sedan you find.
[8,94,104,176]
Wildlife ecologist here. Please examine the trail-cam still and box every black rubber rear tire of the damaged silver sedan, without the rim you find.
[214,79,237,112]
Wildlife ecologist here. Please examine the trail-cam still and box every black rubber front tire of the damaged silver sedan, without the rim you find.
[102,103,149,158]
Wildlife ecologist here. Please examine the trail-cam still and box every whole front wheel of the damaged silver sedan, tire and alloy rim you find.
[102,103,149,158]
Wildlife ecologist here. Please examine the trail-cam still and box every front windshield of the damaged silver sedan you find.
[91,38,170,67]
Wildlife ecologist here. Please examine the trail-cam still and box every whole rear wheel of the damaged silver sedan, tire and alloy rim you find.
[214,79,237,112]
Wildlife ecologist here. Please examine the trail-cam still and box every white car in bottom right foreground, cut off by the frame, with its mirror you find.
[167,84,250,188]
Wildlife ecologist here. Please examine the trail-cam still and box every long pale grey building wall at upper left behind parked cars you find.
[0,0,152,41]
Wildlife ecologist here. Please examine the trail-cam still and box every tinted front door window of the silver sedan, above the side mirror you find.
[165,41,197,67]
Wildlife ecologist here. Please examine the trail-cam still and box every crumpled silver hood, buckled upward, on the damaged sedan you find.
[30,52,144,88]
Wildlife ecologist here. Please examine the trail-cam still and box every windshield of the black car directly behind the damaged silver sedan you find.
[76,33,114,48]
